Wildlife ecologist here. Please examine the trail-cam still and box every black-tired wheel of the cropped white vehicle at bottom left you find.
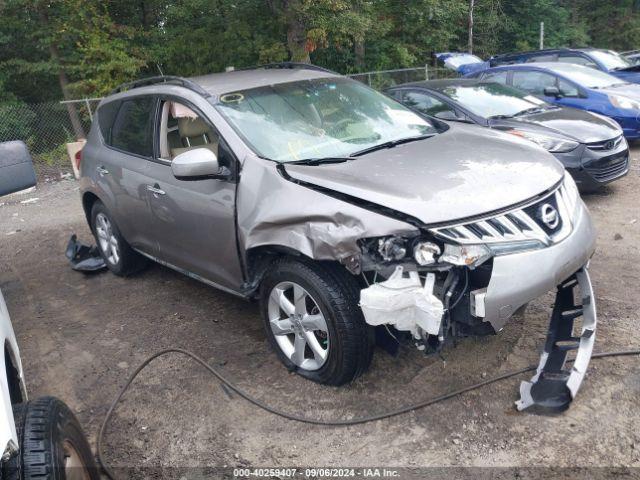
[2,397,100,480]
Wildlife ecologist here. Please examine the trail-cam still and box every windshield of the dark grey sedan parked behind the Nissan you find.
[440,83,548,118]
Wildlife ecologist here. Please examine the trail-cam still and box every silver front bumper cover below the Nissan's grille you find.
[471,200,596,332]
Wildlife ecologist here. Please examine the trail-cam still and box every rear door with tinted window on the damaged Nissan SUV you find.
[94,96,157,255]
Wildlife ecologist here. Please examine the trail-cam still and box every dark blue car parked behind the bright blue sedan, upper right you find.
[488,48,640,83]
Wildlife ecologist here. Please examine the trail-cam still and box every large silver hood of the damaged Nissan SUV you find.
[285,125,564,224]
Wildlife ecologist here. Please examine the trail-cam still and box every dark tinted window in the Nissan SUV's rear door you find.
[107,97,156,157]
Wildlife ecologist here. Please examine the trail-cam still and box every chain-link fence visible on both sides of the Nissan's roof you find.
[0,66,456,165]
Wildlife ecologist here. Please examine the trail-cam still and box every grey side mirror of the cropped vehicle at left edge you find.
[0,141,36,197]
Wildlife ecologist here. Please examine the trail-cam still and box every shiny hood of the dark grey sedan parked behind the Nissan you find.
[492,108,622,143]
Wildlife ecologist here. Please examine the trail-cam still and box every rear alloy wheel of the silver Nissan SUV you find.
[91,201,147,277]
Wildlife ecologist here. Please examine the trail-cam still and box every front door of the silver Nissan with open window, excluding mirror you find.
[145,97,242,291]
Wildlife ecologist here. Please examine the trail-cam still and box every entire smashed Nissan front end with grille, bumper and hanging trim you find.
[359,176,596,410]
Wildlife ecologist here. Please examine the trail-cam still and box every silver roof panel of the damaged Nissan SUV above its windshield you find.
[190,68,340,95]
